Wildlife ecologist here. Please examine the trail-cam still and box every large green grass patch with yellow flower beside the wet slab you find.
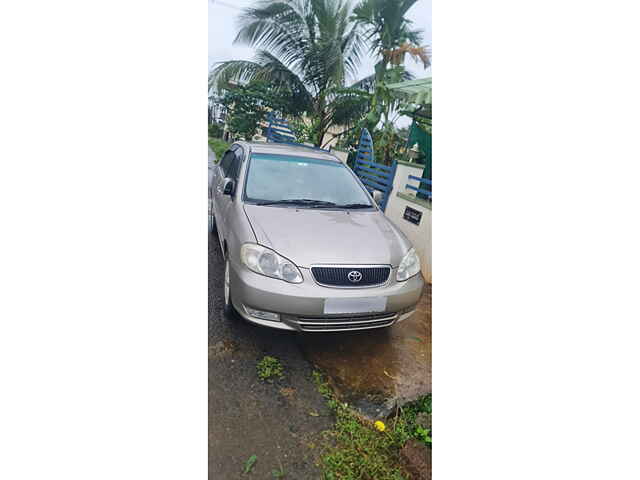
[313,372,431,480]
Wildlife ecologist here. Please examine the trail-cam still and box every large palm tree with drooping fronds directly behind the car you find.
[209,0,365,146]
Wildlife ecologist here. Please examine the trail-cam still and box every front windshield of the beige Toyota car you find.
[245,153,371,208]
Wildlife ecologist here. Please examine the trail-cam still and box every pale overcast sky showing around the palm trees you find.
[209,0,431,83]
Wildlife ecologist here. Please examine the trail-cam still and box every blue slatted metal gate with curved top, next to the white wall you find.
[354,128,397,211]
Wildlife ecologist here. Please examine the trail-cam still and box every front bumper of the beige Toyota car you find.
[229,262,424,332]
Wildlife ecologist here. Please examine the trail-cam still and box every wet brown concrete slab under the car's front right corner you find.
[300,285,431,418]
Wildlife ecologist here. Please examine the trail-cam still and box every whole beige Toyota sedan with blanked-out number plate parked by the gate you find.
[209,142,424,332]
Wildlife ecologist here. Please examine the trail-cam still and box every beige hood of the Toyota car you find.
[245,205,411,268]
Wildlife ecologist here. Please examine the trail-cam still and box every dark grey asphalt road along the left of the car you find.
[209,236,333,480]
